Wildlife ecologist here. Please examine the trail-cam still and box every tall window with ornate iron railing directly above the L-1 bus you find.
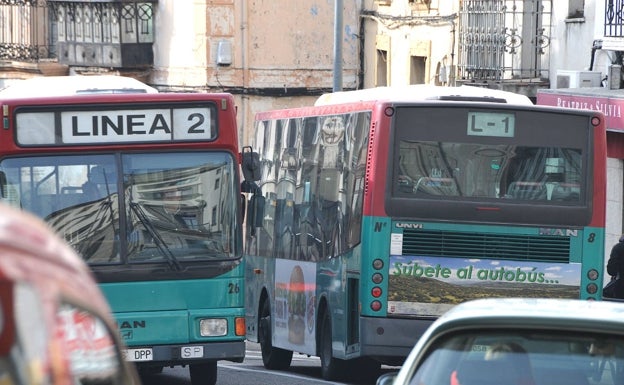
[457,0,552,82]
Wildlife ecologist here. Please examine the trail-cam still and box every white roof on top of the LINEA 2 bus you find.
[0,75,158,98]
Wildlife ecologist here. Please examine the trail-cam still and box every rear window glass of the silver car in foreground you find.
[410,331,624,385]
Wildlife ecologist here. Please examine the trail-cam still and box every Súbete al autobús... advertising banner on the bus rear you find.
[388,255,581,316]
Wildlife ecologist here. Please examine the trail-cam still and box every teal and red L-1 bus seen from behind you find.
[245,82,606,379]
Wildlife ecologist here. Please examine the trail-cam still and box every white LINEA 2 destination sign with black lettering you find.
[16,106,216,145]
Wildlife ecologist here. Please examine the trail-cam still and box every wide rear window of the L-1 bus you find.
[395,140,582,203]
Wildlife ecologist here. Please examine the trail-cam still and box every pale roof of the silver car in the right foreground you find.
[430,298,624,334]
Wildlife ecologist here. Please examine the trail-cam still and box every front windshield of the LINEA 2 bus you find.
[0,152,237,268]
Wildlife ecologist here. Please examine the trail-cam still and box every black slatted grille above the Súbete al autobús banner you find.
[403,229,570,262]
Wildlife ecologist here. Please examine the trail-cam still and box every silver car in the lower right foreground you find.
[377,298,624,385]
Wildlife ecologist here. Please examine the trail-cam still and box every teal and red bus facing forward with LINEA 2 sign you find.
[0,81,245,385]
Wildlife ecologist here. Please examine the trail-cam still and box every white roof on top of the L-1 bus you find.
[314,84,533,106]
